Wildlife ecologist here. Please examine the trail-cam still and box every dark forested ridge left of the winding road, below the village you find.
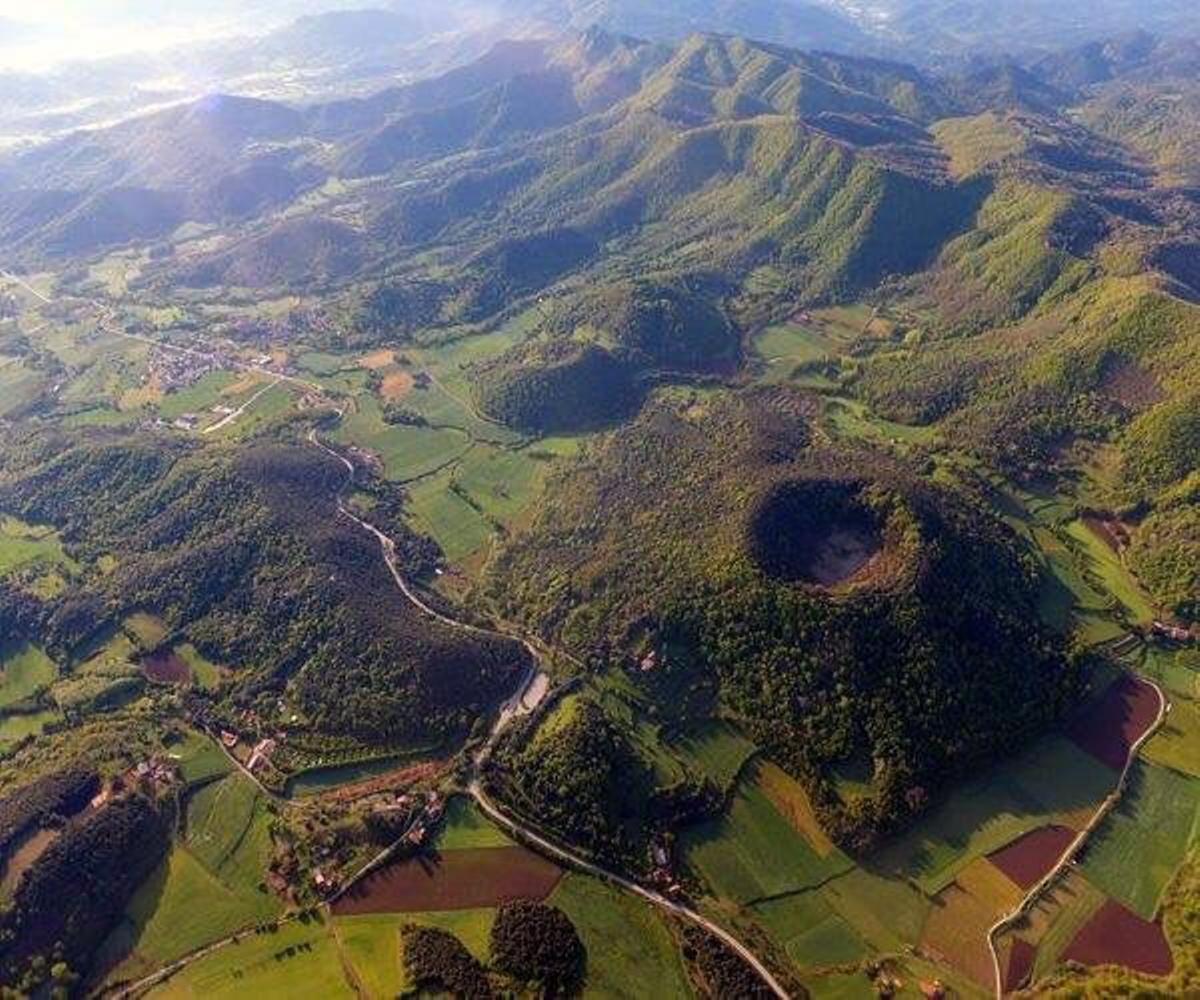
[0,435,526,743]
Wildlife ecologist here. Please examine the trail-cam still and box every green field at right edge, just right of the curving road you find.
[1081,762,1200,920]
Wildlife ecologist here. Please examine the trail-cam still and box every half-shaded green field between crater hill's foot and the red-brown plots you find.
[874,737,1116,896]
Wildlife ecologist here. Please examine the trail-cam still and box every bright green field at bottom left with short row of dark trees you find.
[146,921,355,1000]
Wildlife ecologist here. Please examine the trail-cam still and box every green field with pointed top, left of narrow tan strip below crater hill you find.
[683,773,851,904]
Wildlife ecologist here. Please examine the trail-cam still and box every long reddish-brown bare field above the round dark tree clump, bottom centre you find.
[332,848,563,916]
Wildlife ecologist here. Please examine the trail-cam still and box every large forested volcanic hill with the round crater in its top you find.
[490,390,1082,849]
